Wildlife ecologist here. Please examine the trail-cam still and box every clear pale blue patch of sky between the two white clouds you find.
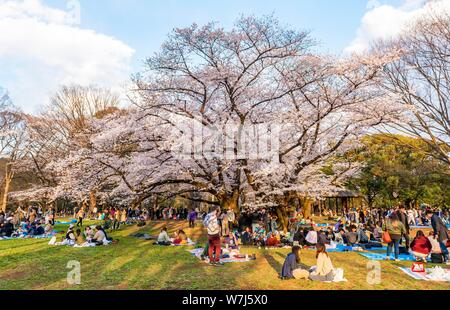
[46,0,372,70]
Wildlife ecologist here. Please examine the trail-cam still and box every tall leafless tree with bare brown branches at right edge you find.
[382,10,450,165]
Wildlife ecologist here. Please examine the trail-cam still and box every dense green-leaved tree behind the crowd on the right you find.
[346,134,450,207]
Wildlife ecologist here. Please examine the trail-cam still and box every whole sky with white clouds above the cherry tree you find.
[0,0,436,113]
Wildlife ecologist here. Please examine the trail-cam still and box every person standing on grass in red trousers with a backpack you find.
[203,207,223,266]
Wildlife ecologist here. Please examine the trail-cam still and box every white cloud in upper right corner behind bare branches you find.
[344,0,450,53]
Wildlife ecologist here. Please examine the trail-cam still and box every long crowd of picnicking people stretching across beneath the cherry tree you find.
[0,201,449,265]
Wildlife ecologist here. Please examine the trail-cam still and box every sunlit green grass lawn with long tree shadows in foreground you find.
[0,222,450,290]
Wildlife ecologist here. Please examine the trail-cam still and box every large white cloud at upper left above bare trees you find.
[0,0,134,112]
